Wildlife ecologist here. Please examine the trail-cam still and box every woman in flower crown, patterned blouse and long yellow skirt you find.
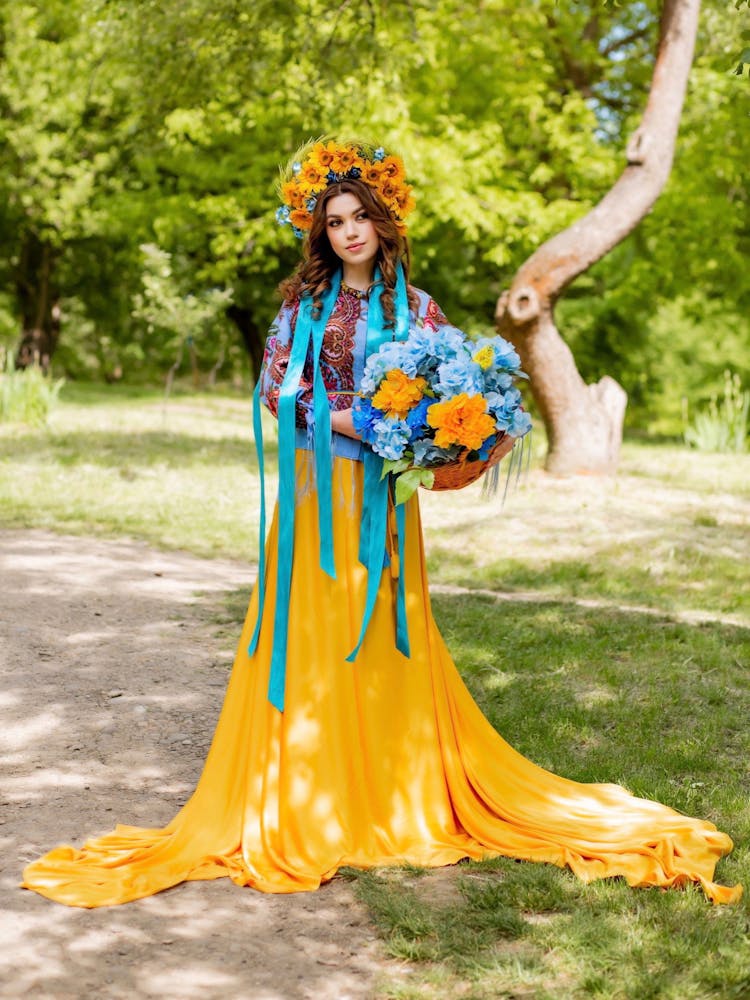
[23,141,741,907]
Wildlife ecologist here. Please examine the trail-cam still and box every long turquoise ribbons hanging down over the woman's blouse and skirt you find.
[253,264,409,712]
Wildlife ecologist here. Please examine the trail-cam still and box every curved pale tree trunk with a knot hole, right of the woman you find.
[495,0,700,475]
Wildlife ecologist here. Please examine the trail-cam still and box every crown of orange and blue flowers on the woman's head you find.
[276,138,415,239]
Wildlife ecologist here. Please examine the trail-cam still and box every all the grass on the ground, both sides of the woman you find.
[0,386,750,1000]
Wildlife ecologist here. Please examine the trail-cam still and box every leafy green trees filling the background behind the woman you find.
[0,0,750,432]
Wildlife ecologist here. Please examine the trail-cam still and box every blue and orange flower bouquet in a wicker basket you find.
[353,326,531,504]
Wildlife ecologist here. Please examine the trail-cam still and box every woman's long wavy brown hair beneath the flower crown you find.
[279,180,418,326]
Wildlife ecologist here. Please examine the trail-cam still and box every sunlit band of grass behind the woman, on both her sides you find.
[0,383,750,632]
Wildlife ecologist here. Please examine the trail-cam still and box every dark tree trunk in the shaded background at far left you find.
[16,232,60,371]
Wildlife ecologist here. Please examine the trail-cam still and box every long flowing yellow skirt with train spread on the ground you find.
[23,452,742,907]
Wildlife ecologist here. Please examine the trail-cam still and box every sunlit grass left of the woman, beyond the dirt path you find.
[0,386,280,560]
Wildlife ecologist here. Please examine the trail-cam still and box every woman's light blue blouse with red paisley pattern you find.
[260,282,448,461]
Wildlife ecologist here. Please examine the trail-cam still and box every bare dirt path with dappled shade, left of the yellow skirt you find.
[0,531,407,1000]
